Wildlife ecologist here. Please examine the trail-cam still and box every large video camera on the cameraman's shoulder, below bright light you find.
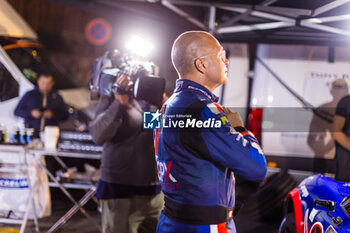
[89,50,165,105]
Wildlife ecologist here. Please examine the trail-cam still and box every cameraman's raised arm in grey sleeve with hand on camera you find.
[89,76,129,145]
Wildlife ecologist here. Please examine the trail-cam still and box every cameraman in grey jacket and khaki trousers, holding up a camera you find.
[90,75,163,233]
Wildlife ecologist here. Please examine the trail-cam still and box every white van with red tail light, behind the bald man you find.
[248,44,350,172]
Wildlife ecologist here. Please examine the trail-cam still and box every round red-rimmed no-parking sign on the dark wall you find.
[85,18,112,45]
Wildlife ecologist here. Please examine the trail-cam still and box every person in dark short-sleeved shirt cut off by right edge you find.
[333,95,350,181]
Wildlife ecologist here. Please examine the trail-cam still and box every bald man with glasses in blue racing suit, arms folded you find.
[154,31,267,233]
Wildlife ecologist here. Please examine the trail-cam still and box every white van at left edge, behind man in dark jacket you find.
[0,0,90,137]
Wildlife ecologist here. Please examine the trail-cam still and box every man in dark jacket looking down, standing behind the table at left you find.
[15,73,68,137]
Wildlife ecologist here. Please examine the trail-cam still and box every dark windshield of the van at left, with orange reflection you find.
[4,43,76,89]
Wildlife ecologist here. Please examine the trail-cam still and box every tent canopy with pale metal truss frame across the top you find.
[51,0,350,44]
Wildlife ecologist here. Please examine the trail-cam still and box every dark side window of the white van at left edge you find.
[0,63,19,102]
